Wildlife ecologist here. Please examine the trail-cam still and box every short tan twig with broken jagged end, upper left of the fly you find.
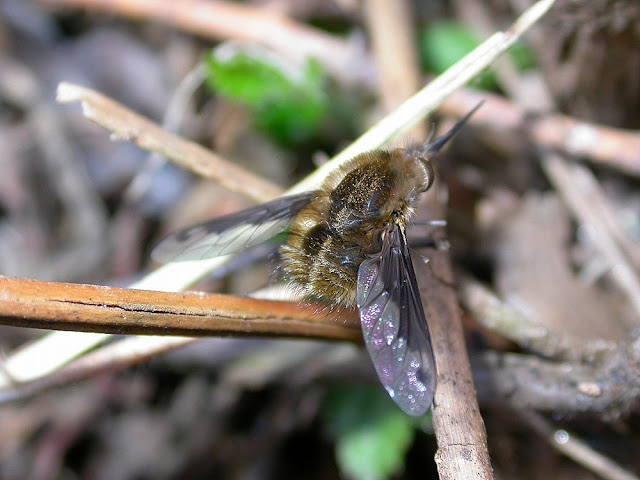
[57,83,282,201]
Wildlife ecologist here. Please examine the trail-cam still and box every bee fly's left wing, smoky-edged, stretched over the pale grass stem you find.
[151,192,316,263]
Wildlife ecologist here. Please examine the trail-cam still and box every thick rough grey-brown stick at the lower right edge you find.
[473,332,640,422]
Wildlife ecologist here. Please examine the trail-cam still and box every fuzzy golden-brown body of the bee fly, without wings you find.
[281,150,431,306]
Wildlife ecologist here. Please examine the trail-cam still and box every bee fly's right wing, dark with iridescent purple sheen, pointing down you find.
[356,226,436,416]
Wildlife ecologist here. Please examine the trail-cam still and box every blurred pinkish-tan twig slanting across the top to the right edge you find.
[41,0,640,177]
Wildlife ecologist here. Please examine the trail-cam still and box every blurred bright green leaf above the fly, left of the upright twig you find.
[207,50,329,143]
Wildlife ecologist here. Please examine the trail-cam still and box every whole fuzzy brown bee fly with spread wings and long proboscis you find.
[151,105,480,416]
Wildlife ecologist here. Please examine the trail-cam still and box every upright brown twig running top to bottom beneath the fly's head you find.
[367,0,493,479]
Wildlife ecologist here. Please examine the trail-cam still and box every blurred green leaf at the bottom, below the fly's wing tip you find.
[324,387,414,480]
